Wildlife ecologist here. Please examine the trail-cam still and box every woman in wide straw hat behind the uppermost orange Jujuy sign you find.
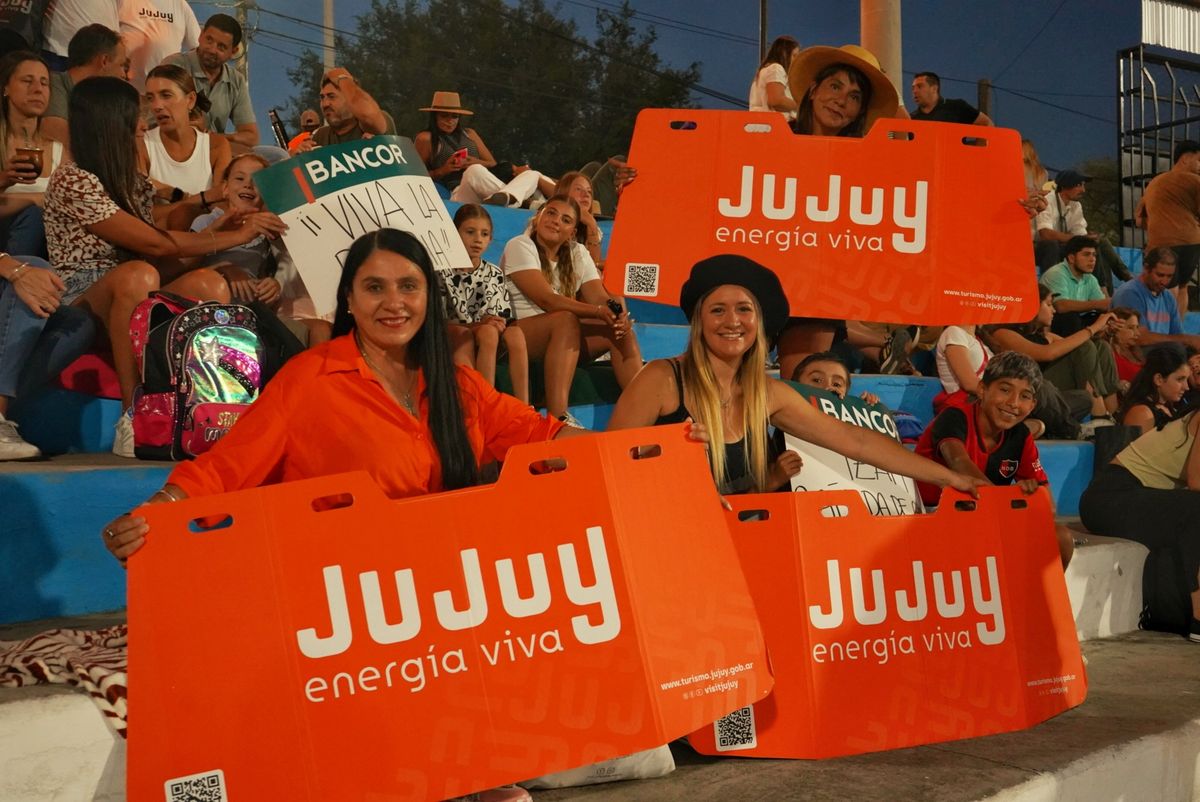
[778,44,900,376]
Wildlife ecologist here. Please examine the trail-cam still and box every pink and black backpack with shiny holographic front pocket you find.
[130,292,263,460]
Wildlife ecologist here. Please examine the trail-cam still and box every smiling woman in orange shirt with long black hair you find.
[104,228,584,561]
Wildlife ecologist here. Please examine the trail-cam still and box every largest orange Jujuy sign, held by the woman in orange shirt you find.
[128,426,772,802]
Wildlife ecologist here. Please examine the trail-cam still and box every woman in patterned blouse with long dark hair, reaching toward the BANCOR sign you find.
[46,77,284,457]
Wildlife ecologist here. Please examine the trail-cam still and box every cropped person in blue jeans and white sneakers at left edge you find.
[0,253,96,461]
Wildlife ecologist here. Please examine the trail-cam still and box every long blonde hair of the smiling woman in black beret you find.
[679,292,769,492]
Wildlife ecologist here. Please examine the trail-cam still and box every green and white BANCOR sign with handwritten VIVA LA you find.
[254,136,470,315]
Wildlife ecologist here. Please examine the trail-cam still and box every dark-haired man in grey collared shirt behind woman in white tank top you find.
[163,14,258,152]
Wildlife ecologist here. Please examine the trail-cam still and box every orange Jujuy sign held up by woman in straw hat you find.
[605,109,1038,325]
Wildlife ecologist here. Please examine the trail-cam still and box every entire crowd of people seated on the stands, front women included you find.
[0,14,1200,798]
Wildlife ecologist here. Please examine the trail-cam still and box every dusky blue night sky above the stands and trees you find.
[204,0,1141,170]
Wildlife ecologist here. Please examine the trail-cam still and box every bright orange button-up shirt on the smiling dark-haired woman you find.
[168,335,563,498]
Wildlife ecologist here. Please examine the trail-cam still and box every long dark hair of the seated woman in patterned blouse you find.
[67,76,154,226]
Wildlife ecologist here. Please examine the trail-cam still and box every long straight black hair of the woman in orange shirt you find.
[334,228,479,490]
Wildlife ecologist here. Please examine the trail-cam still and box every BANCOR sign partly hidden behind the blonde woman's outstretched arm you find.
[785,384,923,516]
